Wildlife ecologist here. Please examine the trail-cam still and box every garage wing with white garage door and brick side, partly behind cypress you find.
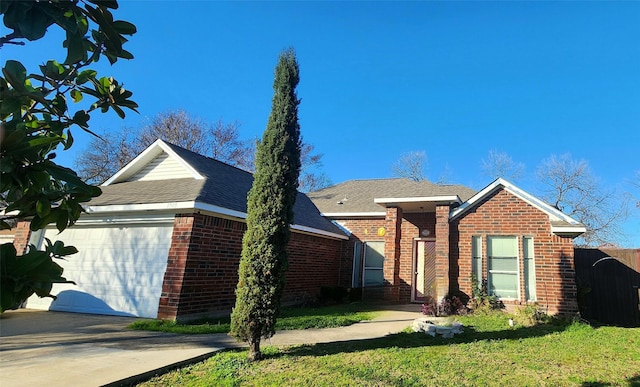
[15,140,347,319]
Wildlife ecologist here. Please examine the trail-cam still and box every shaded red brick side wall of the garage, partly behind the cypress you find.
[158,214,340,319]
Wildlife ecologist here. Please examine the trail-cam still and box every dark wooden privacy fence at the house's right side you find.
[574,248,640,327]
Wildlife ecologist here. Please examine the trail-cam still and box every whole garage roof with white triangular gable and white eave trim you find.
[87,140,345,238]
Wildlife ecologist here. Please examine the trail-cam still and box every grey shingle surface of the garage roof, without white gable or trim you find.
[89,142,344,235]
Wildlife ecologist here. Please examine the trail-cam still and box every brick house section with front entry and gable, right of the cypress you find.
[308,179,586,314]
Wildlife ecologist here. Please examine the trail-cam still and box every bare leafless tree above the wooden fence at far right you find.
[537,154,628,246]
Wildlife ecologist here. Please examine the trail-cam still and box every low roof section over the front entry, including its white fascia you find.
[307,178,475,218]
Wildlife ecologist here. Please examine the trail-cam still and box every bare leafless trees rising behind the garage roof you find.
[75,110,253,183]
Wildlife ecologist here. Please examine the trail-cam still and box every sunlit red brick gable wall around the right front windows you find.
[450,190,578,314]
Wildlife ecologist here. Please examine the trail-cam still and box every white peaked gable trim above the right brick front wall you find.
[449,178,587,237]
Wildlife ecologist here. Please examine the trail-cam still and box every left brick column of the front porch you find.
[383,207,402,302]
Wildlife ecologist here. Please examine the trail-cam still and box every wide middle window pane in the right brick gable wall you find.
[487,236,518,299]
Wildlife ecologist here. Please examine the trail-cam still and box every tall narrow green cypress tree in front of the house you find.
[230,49,300,361]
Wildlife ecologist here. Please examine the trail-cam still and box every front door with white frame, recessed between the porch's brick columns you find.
[412,240,436,302]
